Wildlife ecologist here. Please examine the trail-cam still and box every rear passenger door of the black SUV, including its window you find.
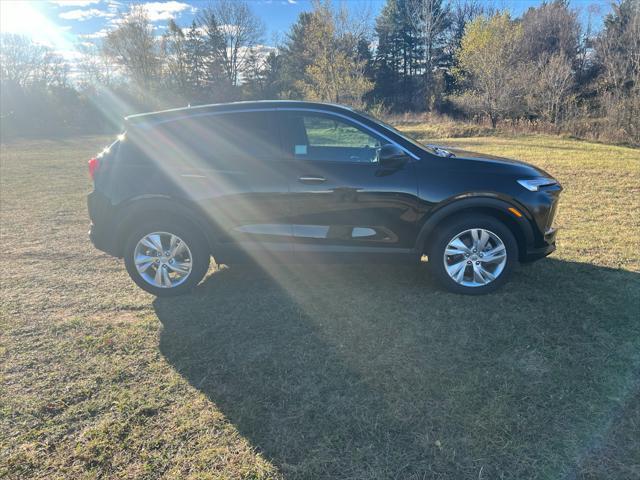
[159,111,292,256]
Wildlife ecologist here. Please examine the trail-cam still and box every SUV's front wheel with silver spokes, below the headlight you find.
[426,214,518,295]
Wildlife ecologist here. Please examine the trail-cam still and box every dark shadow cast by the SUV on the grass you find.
[154,259,640,479]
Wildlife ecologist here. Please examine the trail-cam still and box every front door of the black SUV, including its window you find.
[279,110,420,257]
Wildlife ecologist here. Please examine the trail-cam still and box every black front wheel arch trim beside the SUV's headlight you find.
[416,196,534,260]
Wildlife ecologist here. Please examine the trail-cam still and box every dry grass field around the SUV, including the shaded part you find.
[0,132,640,480]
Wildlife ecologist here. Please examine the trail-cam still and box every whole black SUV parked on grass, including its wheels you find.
[88,101,562,296]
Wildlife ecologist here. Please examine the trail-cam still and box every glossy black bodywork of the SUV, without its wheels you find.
[88,101,561,261]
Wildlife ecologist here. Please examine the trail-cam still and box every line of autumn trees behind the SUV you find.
[0,0,640,144]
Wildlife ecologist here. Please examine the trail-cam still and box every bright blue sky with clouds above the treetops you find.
[0,0,609,59]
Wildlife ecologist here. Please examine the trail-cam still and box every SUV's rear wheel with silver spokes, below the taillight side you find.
[124,219,211,297]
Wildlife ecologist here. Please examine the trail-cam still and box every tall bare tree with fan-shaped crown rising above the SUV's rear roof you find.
[199,0,264,86]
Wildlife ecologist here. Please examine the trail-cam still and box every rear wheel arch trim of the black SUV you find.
[114,195,216,257]
